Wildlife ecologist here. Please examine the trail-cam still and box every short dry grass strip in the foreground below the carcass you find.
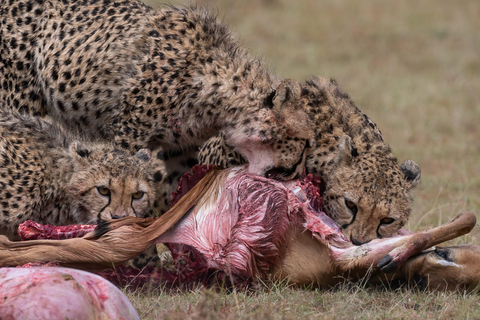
[127,284,480,320]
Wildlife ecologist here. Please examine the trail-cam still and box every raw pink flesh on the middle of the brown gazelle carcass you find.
[157,167,349,278]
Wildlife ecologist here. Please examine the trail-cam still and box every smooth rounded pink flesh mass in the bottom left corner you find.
[0,267,140,320]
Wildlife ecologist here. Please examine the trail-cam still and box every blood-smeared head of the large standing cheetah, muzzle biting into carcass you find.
[225,79,314,180]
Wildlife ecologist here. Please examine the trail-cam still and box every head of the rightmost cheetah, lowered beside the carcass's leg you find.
[324,135,420,244]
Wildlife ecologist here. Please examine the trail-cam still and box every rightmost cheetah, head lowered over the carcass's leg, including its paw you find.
[198,77,421,245]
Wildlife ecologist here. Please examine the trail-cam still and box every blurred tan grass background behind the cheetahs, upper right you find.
[145,0,480,243]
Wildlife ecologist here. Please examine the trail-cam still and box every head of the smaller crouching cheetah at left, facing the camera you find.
[67,142,155,223]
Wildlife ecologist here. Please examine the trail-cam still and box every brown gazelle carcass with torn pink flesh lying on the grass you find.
[0,167,480,289]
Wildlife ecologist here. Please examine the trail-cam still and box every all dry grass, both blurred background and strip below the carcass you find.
[129,0,480,319]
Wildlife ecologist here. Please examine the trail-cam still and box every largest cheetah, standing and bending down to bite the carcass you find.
[0,0,313,213]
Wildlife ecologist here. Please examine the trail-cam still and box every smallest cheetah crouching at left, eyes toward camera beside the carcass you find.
[0,111,155,238]
